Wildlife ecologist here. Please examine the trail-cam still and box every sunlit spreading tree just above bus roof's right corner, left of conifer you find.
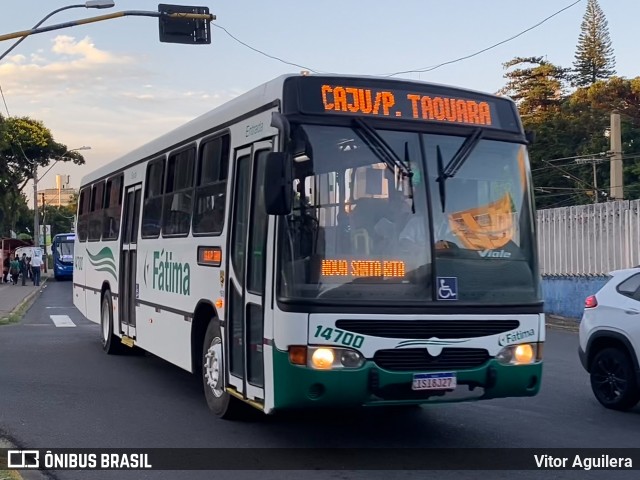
[499,57,568,117]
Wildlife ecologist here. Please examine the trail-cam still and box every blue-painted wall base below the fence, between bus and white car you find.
[542,275,609,319]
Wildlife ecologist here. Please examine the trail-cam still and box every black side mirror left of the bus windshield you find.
[264,152,293,215]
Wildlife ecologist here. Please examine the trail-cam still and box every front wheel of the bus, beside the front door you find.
[202,318,244,420]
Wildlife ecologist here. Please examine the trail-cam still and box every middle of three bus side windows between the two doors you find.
[162,147,196,235]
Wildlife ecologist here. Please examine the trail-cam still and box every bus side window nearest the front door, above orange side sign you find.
[193,135,230,235]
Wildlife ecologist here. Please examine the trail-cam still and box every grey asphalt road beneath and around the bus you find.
[0,281,640,480]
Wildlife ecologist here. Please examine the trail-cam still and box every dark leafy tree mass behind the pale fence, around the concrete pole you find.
[523,77,640,208]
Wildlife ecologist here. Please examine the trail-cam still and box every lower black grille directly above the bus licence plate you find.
[373,348,489,372]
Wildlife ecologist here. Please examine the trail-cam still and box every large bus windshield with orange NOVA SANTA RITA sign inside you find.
[278,125,539,305]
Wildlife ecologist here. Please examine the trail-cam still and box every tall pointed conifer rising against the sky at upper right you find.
[573,0,615,87]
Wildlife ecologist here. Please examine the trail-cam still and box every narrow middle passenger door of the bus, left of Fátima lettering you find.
[118,184,142,338]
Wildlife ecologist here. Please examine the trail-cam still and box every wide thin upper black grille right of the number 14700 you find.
[336,320,520,339]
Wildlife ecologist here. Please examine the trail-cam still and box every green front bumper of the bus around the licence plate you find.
[274,350,542,410]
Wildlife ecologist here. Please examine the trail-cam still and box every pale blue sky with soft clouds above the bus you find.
[0,0,640,203]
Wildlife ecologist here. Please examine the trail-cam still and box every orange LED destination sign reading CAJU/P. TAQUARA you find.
[321,84,496,127]
